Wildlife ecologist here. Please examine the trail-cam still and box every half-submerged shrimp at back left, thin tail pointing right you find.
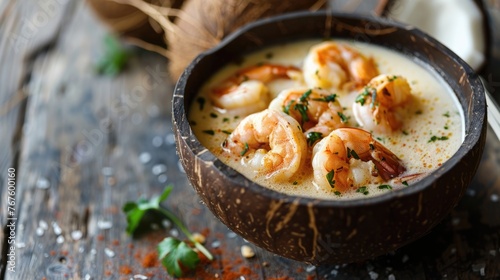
[209,64,302,114]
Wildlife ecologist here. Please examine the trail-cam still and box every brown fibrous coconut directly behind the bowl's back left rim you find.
[166,0,326,81]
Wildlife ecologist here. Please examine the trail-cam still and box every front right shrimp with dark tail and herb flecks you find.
[312,128,406,193]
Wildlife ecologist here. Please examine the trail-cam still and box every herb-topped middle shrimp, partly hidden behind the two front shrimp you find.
[269,88,348,146]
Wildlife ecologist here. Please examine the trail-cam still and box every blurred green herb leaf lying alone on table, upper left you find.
[96,35,130,76]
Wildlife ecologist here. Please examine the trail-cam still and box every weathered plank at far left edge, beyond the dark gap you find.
[0,0,69,276]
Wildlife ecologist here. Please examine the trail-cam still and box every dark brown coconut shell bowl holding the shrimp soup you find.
[173,11,487,265]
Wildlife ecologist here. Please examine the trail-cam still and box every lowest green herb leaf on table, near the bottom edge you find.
[157,237,200,277]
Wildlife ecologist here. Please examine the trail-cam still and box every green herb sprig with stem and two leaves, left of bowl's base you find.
[123,186,213,277]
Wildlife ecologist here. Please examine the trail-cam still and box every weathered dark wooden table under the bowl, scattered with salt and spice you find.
[0,0,500,279]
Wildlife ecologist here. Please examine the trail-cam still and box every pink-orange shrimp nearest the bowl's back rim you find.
[303,42,378,89]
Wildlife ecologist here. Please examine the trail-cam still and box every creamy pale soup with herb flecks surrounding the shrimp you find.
[188,40,464,199]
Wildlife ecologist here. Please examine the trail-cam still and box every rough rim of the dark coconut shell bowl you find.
[172,10,486,208]
